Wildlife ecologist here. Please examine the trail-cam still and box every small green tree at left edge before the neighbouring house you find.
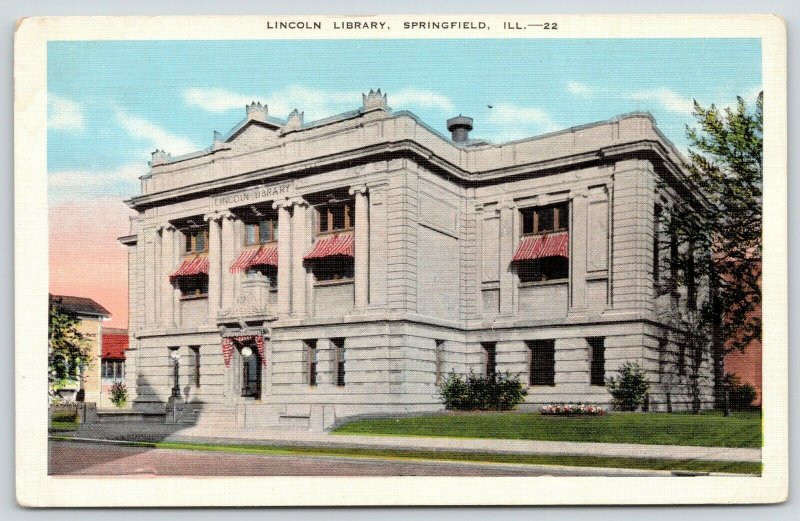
[48,305,92,390]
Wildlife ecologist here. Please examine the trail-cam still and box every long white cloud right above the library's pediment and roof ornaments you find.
[183,85,455,120]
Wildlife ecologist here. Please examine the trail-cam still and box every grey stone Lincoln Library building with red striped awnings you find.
[120,91,711,429]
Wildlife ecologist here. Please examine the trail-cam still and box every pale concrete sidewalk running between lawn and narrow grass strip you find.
[65,423,761,462]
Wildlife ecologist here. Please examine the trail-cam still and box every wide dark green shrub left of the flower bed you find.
[439,372,528,411]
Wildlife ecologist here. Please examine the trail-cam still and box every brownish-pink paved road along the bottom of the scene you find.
[49,441,664,476]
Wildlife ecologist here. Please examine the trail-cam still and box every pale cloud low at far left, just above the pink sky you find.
[47,163,147,201]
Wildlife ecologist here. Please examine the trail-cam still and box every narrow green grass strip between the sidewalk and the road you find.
[54,437,761,474]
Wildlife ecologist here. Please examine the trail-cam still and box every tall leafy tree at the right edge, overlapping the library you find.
[662,93,764,407]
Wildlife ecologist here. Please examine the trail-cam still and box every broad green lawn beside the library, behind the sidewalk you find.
[334,411,761,447]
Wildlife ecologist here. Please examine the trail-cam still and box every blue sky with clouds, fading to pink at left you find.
[47,39,761,327]
